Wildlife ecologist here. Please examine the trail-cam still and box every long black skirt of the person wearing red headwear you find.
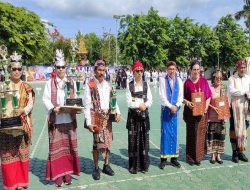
[127,111,150,173]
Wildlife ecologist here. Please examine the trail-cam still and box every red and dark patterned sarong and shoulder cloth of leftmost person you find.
[0,82,35,190]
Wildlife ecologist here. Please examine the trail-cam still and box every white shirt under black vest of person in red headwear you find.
[126,81,153,108]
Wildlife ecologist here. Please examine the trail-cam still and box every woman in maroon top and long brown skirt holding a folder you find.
[183,60,211,166]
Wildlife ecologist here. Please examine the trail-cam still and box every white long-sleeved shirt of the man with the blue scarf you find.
[159,77,183,108]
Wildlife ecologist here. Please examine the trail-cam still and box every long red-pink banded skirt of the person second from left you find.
[46,123,80,181]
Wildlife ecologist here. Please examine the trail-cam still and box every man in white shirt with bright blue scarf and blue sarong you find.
[159,61,183,169]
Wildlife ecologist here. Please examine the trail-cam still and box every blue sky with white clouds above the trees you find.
[0,0,244,38]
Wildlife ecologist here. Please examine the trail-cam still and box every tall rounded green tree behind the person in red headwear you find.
[118,8,171,68]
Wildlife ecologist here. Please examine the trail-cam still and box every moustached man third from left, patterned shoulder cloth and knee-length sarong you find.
[83,60,120,180]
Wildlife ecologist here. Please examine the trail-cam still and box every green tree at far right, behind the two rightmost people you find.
[215,15,250,68]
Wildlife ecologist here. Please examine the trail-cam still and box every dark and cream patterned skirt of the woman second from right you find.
[207,122,226,154]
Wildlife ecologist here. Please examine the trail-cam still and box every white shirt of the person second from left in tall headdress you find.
[43,76,76,124]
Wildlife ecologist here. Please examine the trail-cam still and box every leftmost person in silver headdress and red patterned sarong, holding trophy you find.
[0,52,35,190]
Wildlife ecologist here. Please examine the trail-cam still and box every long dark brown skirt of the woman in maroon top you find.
[184,109,207,163]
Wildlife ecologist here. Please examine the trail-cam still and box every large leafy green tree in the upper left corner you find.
[0,3,48,64]
